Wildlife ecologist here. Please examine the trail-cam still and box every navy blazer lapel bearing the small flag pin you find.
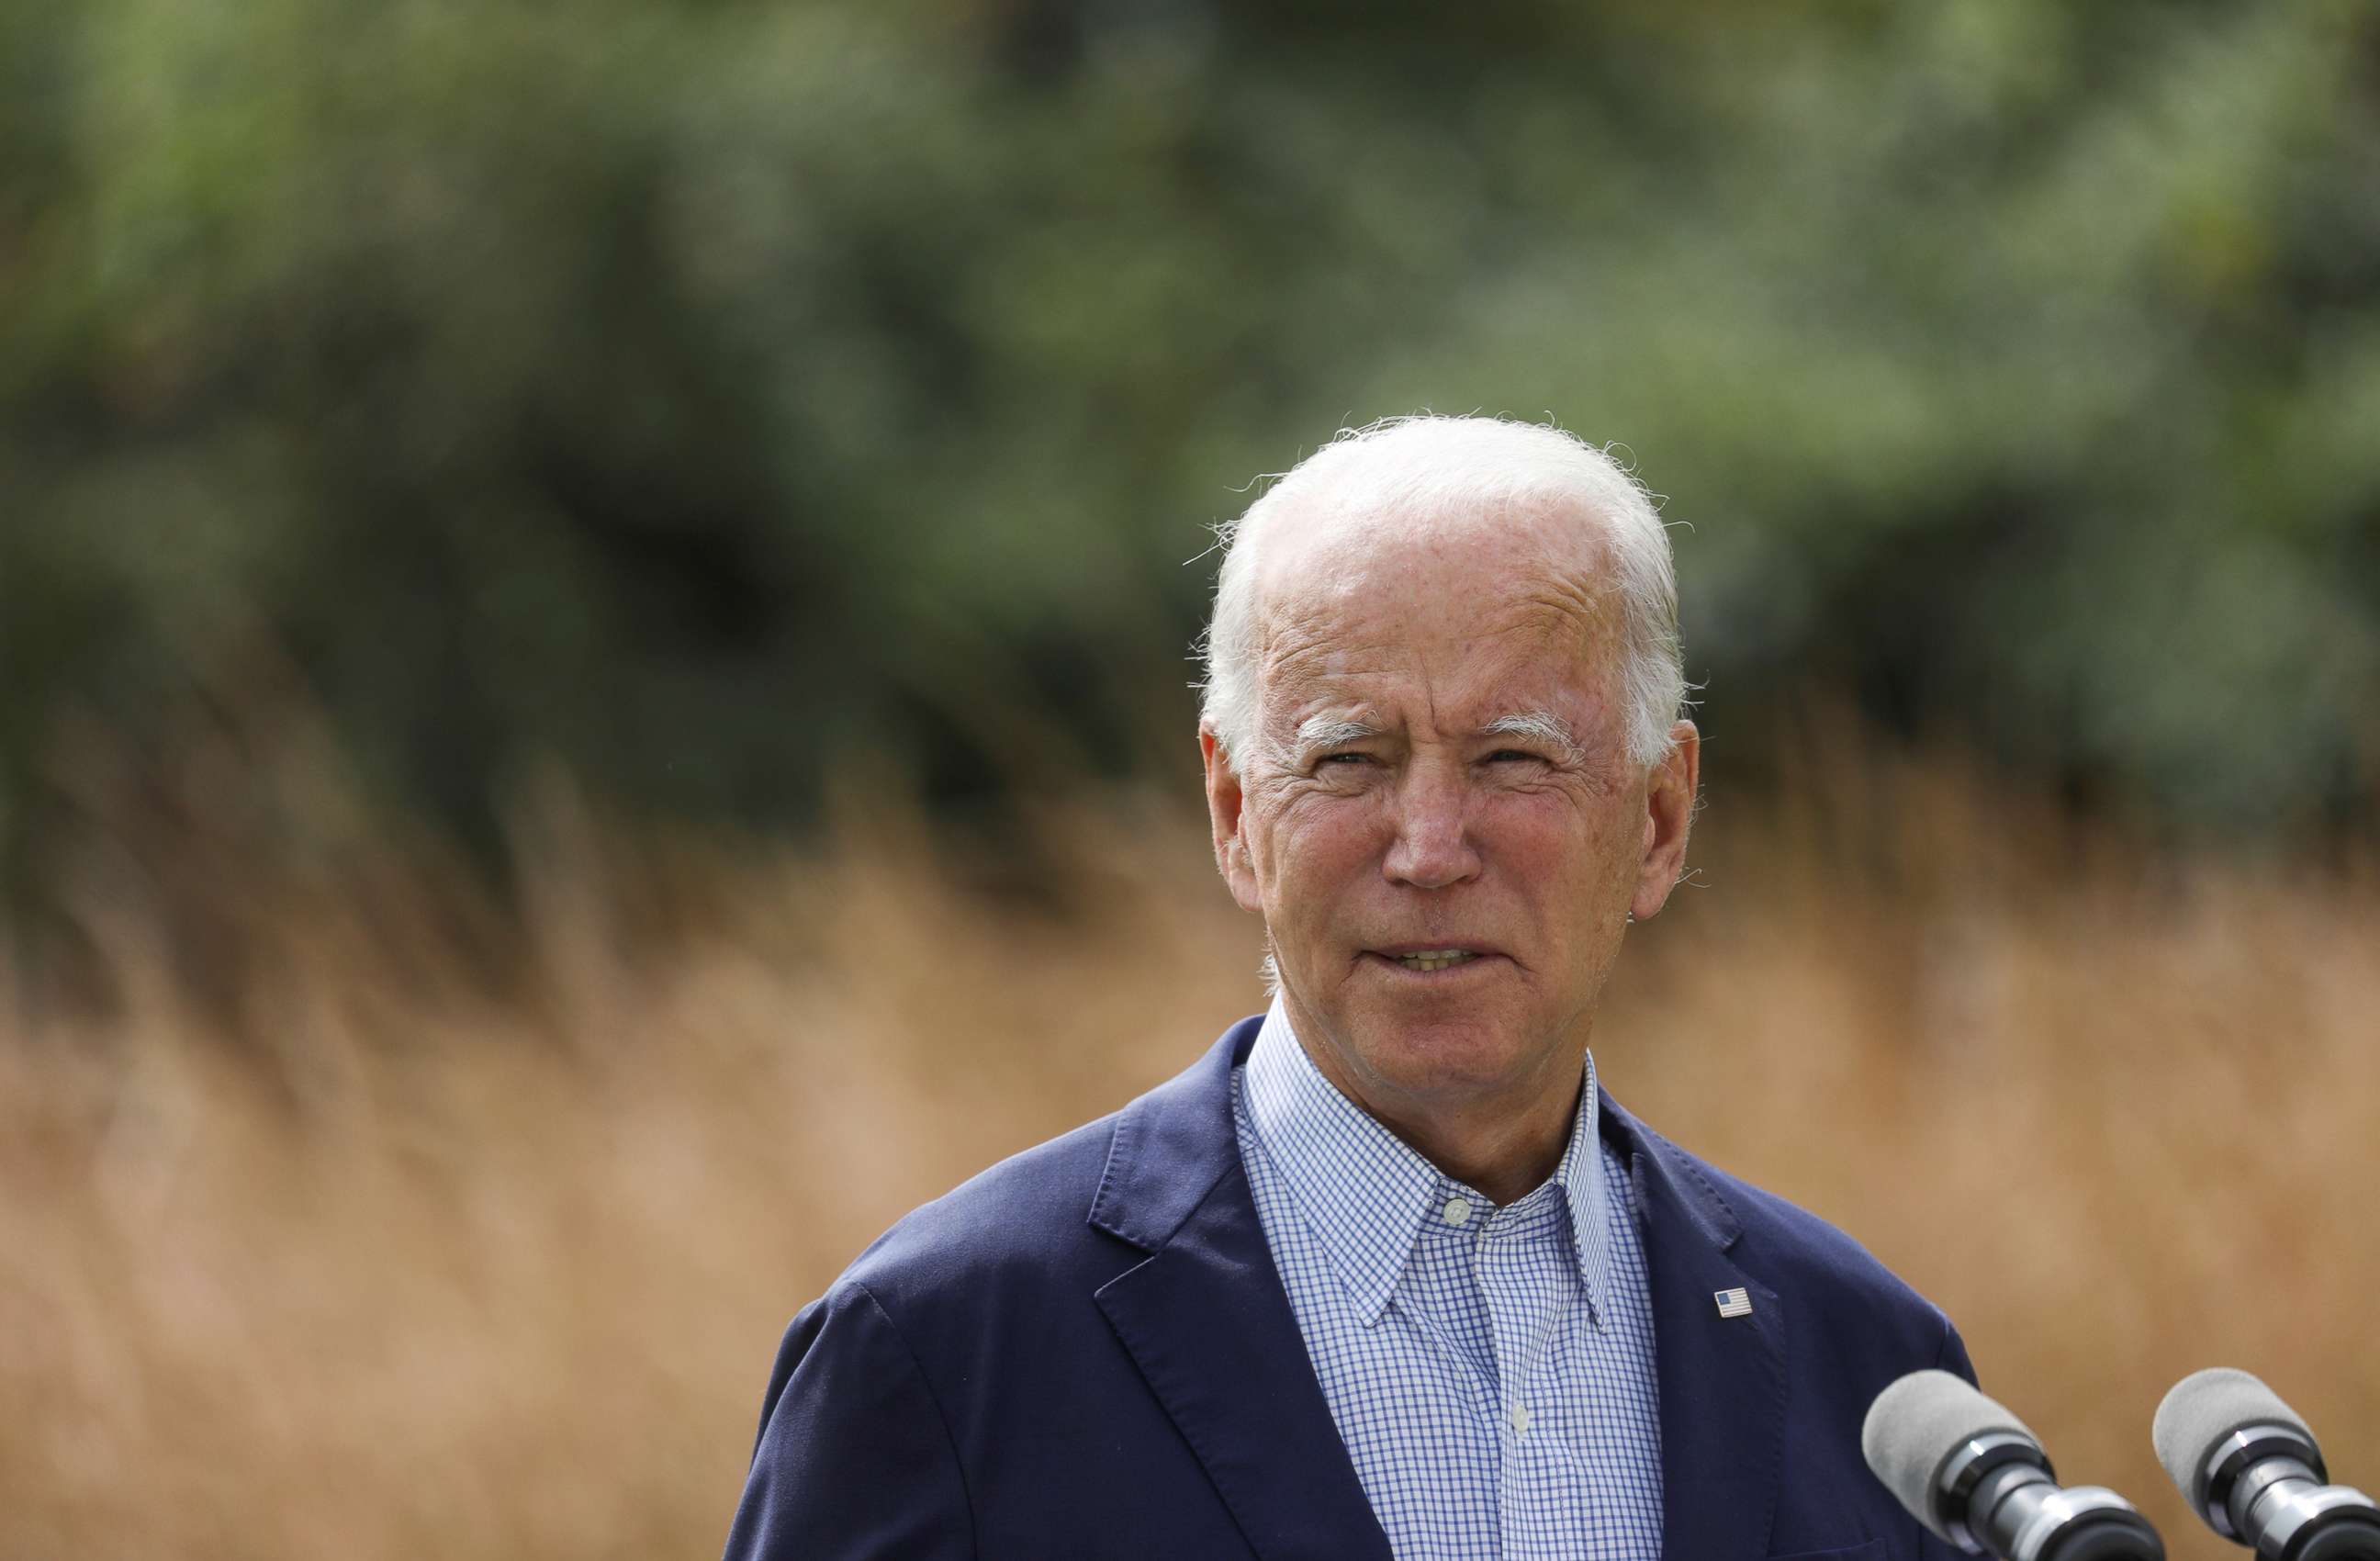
[1601,1095,1785,1561]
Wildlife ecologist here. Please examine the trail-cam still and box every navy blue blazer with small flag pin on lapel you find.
[726,1018,1973,1561]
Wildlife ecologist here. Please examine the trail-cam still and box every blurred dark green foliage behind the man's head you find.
[0,0,2380,875]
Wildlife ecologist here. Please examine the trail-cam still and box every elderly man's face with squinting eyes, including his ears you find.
[1202,514,1697,1126]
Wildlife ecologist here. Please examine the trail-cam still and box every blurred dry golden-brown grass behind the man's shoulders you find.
[0,751,2380,1558]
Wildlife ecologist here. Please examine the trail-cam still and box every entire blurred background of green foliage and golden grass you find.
[0,0,2380,1558]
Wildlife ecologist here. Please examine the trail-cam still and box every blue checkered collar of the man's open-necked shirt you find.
[1247,997,1609,1325]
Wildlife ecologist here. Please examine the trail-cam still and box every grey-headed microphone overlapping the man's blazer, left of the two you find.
[1858,1371,2166,1561]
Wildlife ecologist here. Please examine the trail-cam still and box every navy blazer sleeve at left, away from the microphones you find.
[726,1283,976,1561]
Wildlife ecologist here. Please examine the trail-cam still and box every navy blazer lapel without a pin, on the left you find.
[1090,1021,1389,1561]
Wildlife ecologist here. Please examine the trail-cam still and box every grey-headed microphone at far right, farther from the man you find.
[2150,1366,2380,1561]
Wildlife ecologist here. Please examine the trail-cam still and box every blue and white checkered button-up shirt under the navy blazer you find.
[1233,1002,1661,1561]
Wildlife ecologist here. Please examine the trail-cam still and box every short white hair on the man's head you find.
[1199,414,1688,773]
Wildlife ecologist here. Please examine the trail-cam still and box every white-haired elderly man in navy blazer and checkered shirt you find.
[728,419,1969,1561]
